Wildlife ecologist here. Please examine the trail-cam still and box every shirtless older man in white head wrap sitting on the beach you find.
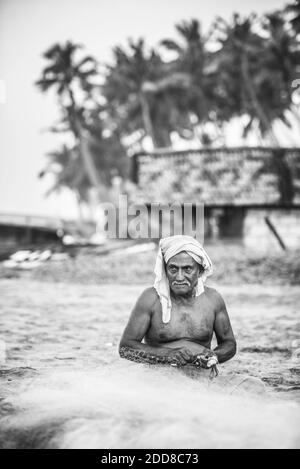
[119,236,236,370]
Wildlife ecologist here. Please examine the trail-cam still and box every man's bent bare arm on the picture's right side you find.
[214,291,236,363]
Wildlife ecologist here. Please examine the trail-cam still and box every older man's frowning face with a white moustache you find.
[166,252,200,295]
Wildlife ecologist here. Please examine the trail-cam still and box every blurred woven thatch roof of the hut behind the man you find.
[132,147,300,241]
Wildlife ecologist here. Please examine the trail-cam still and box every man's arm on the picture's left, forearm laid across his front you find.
[119,288,192,365]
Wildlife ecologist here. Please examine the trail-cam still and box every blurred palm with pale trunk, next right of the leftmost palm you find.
[103,39,189,147]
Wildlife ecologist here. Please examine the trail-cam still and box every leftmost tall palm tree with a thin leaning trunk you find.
[36,41,102,197]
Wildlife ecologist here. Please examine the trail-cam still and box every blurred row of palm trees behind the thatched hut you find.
[35,0,300,207]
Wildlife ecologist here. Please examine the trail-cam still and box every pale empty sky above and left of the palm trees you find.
[0,0,286,218]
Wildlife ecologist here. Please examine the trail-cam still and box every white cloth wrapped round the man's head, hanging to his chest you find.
[154,235,212,323]
